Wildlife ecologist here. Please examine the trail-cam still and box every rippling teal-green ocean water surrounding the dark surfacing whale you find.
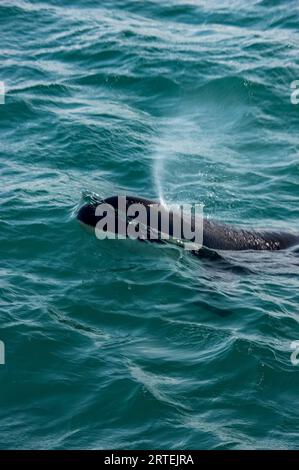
[0,0,299,449]
